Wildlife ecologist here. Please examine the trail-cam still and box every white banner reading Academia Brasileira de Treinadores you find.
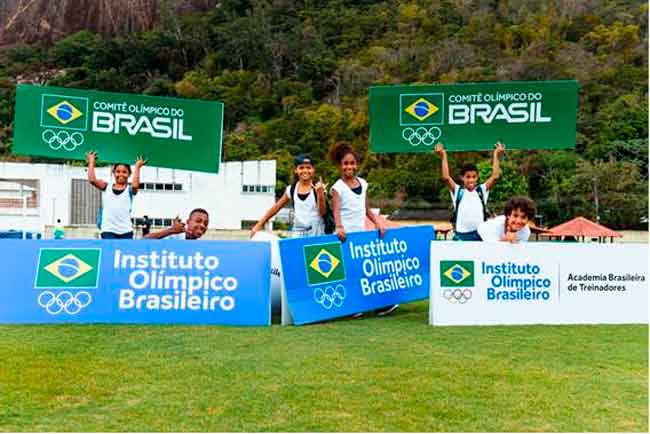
[429,241,649,325]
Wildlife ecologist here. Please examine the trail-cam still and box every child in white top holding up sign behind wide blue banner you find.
[86,151,146,239]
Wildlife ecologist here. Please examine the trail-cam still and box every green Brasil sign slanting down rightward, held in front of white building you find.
[12,85,223,173]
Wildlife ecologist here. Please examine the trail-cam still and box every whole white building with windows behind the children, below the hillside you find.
[0,160,276,232]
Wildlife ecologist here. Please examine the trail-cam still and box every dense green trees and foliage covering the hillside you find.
[0,0,648,228]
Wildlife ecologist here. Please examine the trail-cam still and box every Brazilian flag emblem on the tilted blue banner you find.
[303,242,345,285]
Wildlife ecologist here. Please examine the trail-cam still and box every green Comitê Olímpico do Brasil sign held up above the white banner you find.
[370,80,578,152]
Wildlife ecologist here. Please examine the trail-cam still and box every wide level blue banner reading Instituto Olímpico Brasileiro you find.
[0,240,271,326]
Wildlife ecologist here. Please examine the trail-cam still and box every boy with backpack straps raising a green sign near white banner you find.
[436,142,505,241]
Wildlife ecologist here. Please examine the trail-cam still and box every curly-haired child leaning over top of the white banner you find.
[478,197,535,243]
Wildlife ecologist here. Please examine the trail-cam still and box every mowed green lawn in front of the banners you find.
[0,302,648,432]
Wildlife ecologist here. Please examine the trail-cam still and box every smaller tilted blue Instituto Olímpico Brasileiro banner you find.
[280,226,435,324]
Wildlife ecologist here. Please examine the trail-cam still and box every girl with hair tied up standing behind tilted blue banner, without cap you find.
[330,142,399,318]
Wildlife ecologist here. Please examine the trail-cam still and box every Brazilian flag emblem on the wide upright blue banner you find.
[34,249,101,288]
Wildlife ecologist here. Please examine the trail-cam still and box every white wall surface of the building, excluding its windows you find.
[0,160,276,231]
